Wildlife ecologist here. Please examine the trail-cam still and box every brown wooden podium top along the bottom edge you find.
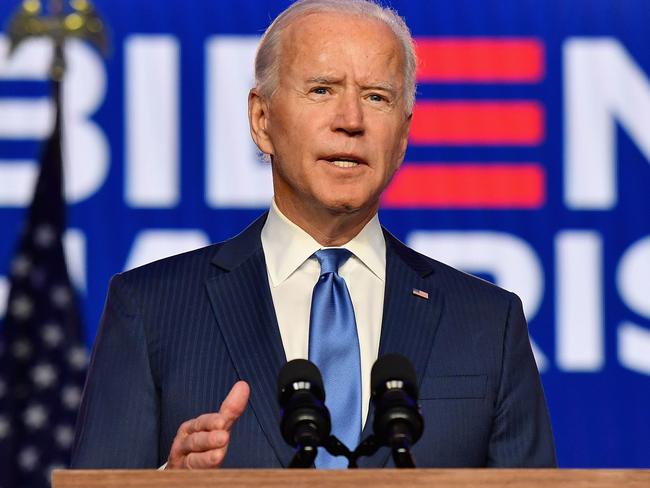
[52,469,650,488]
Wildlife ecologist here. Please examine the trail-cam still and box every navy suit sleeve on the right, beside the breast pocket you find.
[487,294,557,468]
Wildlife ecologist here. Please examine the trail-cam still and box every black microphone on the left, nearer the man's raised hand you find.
[278,359,332,468]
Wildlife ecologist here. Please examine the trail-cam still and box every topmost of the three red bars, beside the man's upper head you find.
[416,37,545,83]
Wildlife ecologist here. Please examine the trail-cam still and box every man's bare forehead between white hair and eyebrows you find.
[280,13,404,81]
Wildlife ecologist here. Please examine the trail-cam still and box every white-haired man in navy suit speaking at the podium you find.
[73,0,555,469]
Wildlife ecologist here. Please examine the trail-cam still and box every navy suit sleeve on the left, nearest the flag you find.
[71,275,160,468]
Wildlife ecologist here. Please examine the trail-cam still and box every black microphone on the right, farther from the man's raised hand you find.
[370,354,424,468]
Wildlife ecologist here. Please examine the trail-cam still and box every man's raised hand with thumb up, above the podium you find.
[166,381,250,469]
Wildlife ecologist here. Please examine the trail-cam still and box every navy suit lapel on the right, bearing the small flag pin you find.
[359,230,443,468]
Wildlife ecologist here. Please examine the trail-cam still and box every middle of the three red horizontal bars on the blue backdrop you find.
[411,101,544,146]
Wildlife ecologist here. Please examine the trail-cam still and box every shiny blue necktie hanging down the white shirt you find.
[309,249,361,469]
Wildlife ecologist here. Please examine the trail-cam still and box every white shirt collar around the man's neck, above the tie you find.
[261,201,386,287]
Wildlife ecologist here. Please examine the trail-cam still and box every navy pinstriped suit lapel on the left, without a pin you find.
[206,216,293,466]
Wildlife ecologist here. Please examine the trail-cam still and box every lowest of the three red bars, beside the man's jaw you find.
[382,163,546,209]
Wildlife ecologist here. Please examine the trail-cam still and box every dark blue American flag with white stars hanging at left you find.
[0,81,87,488]
